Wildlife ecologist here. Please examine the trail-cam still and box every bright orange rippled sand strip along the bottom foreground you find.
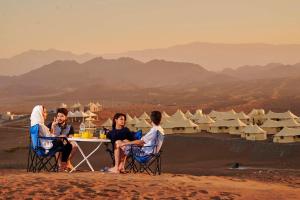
[0,170,300,200]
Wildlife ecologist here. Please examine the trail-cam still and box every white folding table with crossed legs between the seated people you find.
[68,137,111,173]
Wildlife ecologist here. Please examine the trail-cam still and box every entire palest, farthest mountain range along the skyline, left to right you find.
[0,42,300,76]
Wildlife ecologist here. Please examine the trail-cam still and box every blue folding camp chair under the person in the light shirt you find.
[128,131,164,175]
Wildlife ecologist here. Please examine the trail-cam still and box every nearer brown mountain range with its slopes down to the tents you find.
[0,57,300,113]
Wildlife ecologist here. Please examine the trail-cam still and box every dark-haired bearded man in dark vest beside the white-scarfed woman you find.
[48,108,78,170]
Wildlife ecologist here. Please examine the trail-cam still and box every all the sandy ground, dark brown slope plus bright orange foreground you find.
[0,127,300,200]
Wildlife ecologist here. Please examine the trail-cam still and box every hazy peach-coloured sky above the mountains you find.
[0,0,300,57]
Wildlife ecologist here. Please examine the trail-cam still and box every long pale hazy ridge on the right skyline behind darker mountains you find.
[103,42,300,71]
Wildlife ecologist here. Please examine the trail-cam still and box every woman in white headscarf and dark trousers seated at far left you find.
[30,105,72,171]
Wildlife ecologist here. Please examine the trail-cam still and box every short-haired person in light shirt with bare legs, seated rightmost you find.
[108,111,164,173]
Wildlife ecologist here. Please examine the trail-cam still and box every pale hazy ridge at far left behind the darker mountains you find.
[0,49,95,76]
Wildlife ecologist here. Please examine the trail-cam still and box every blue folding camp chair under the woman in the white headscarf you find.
[27,124,67,172]
